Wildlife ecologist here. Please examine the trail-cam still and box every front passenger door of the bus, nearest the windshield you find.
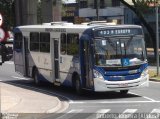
[81,40,93,88]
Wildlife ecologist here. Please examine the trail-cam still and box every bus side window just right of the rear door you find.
[30,32,40,52]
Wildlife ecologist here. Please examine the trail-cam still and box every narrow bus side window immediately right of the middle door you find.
[61,33,67,55]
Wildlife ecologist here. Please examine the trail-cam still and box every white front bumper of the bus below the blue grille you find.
[94,74,149,92]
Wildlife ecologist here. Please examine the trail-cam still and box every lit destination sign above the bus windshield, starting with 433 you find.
[95,28,142,37]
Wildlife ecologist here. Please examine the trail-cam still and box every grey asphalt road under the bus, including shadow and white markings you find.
[0,62,160,119]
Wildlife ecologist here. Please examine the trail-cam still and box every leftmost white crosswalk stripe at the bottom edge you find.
[56,109,83,119]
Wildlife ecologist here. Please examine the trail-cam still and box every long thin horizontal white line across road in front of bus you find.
[69,101,160,104]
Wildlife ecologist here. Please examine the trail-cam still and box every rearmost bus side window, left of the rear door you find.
[14,33,23,50]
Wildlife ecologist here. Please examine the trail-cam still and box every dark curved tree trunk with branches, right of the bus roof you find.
[120,0,158,58]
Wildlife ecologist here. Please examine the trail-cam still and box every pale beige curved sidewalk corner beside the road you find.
[0,82,68,113]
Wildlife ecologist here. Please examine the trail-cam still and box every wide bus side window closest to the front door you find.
[67,34,79,55]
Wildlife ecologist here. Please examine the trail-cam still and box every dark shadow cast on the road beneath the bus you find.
[1,80,141,101]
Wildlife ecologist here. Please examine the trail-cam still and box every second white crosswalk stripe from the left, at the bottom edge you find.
[86,109,110,119]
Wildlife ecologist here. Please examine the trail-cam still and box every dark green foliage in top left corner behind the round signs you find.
[0,0,14,30]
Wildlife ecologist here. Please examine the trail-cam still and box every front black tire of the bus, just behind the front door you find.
[75,75,83,95]
